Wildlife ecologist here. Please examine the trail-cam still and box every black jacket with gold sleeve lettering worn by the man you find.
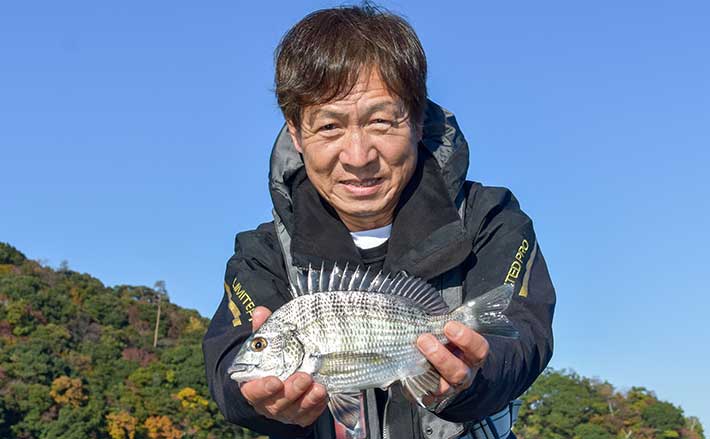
[203,103,555,438]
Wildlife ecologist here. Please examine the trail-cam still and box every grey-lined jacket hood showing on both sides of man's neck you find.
[269,100,468,225]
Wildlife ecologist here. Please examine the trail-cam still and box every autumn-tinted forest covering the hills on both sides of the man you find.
[0,243,705,439]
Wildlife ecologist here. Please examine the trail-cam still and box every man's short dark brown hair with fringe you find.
[275,3,427,129]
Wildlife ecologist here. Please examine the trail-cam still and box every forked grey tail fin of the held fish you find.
[451,284,519,338]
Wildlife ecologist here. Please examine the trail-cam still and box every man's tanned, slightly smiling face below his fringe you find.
[289,69,421,231]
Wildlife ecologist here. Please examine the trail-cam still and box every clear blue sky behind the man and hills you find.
[0,0,710,429]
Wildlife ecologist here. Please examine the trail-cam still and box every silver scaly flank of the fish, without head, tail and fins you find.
[268,291,445,392]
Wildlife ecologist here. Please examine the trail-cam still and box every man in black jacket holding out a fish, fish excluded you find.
[203,6,555,439]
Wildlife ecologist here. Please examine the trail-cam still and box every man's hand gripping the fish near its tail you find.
[417,322,488,407]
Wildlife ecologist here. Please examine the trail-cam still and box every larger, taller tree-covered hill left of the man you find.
[0,243,255,439]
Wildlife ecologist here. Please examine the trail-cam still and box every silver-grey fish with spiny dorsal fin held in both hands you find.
[227,264,518,437]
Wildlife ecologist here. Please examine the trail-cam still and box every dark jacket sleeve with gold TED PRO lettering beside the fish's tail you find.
[438,185,555,422]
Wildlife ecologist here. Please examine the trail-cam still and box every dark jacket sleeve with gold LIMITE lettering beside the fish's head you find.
[202,224,312,438]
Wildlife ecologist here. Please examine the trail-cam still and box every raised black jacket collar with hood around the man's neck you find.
[269,101,471,279]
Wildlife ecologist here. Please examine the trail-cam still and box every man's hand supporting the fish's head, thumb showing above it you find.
[240,306,328,427]
